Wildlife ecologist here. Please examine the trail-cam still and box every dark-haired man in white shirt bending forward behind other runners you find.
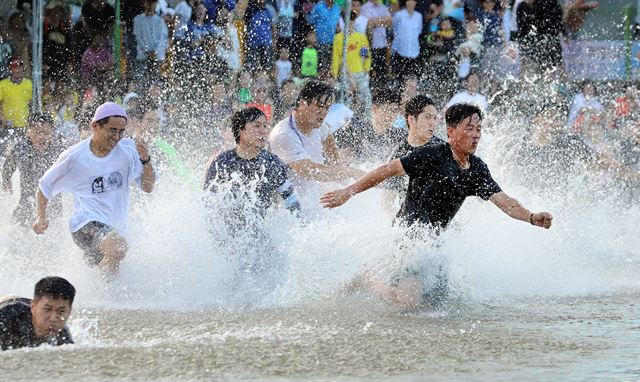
[269,81,364,182]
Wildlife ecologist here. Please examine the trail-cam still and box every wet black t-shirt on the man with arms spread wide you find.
[398,143,501,228]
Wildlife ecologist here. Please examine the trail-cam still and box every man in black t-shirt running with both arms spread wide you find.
[320,104,553,307]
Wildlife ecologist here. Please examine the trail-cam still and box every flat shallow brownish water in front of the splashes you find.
[0,293,640,381]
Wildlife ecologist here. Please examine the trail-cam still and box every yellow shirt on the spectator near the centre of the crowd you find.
[331,32,371,78]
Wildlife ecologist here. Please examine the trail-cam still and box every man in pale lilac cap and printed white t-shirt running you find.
[33,102,156,276]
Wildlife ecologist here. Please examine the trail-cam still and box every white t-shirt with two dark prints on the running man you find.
[38,138,142,233]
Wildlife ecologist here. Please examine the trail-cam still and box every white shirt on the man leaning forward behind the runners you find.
[269,115,331,164]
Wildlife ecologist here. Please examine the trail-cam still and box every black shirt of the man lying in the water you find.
[0,297,73,350]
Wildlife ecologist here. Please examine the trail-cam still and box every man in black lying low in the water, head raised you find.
[0,277,76,350]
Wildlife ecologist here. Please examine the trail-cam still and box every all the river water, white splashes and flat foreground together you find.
[0,121,640,381]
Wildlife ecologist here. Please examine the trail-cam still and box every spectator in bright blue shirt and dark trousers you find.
[309,0,340,78]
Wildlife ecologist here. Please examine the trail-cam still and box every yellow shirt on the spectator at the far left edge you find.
[0,78,32,127]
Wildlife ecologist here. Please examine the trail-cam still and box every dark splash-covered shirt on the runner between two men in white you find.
[204,149,300,215]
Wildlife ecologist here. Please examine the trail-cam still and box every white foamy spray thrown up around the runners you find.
[0,124,640,310]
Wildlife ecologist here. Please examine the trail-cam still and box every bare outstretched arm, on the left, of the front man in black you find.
[320,159,405,208]
